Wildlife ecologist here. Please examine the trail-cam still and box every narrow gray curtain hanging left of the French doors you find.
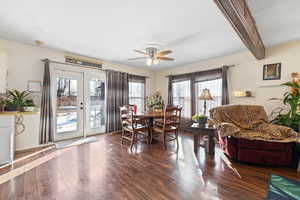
[40,60,54,144]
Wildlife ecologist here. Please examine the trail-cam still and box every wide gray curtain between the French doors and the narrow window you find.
[106,70,129,133]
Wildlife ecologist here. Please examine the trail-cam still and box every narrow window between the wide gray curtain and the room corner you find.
[129,76,146,113]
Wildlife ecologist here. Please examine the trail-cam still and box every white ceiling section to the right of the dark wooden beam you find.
[247,0,300,46]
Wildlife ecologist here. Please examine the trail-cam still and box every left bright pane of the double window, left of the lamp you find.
[172,80,191,118]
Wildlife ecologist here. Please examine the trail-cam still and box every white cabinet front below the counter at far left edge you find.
[0,115,15,165]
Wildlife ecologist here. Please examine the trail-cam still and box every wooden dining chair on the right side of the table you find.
[152,106,182,149]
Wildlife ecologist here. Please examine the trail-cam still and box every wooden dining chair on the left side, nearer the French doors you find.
[120,105,149,150]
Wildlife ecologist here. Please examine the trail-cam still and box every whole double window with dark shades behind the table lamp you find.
[169,68,226,123]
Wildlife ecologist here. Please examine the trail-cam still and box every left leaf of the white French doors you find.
[54,71,83,141]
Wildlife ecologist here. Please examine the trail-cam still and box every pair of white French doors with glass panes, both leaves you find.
[51,67,106,141]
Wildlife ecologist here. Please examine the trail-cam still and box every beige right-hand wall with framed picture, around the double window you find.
[155,41,300,113]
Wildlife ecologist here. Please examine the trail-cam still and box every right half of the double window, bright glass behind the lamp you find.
[195,78,222,115]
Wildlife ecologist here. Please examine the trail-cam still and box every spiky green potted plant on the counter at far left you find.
[5,90,30,112]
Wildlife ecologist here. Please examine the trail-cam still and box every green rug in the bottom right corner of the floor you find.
[266,174,300,200]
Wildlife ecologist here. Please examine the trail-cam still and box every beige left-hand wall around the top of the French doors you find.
[0,39,154,97]
